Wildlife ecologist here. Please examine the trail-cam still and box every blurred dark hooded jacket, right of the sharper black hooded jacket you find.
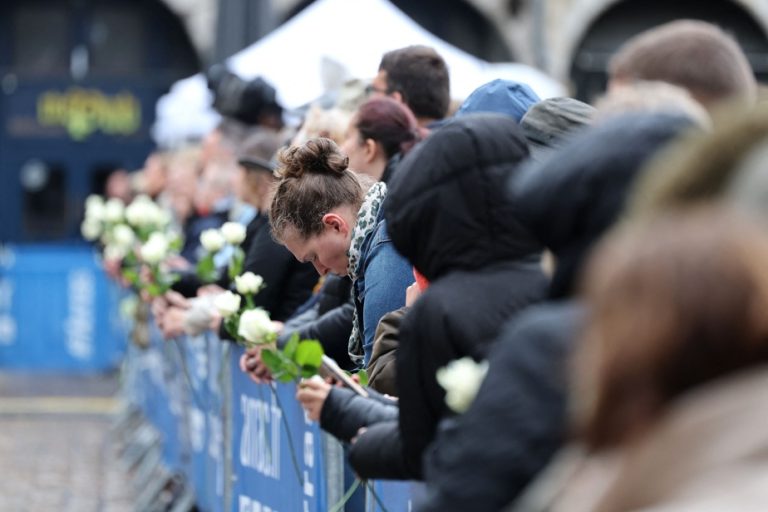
[416,115,690,512]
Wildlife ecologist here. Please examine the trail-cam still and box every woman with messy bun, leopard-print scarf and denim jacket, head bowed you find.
[269,138,413,367]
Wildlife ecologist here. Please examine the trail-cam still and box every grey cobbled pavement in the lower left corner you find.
[0,373,134,512]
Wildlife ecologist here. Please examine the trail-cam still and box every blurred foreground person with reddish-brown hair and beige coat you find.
[515,209,768,512]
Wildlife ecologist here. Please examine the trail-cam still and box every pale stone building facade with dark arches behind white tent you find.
[165,0,768,100]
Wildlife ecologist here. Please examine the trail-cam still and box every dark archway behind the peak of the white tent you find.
[283,0,514,62]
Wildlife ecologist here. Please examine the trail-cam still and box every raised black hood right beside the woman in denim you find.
[385,114,541,281]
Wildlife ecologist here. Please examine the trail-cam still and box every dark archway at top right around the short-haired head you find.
[570,0,768,101]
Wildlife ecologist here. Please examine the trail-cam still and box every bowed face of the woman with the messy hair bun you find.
[283,224,350,276]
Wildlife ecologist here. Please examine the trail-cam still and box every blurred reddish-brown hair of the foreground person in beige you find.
[574,210,768,450]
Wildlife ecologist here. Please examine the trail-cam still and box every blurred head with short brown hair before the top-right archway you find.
[608,20,757,110]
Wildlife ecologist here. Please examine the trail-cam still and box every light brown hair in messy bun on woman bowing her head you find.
[269,137,364,240]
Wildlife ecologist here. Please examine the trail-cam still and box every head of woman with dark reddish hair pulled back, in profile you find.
[341,97,421,183]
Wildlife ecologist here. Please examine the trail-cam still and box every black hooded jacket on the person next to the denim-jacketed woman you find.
[342,114,547,478]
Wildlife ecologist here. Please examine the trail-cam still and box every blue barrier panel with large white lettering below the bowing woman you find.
[225,347,328,512]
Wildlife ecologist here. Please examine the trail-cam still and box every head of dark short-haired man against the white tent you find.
[368,45,451,128]
